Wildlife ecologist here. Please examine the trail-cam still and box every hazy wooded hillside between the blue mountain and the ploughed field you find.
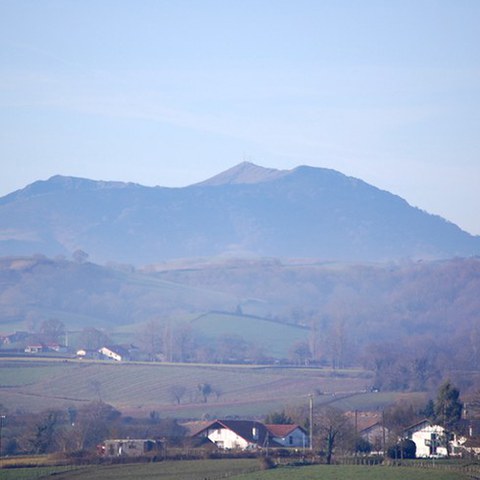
[0,256,480,388]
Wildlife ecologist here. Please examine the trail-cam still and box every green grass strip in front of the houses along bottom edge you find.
[0,459,469,480]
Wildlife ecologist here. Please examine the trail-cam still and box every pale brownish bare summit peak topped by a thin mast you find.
[197,162,289,186]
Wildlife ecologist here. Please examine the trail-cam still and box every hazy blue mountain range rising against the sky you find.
[0,162,480,265]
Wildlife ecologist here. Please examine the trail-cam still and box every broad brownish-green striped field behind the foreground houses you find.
[0,358,395,418]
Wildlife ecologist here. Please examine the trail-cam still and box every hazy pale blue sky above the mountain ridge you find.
[0,0,480,234]
